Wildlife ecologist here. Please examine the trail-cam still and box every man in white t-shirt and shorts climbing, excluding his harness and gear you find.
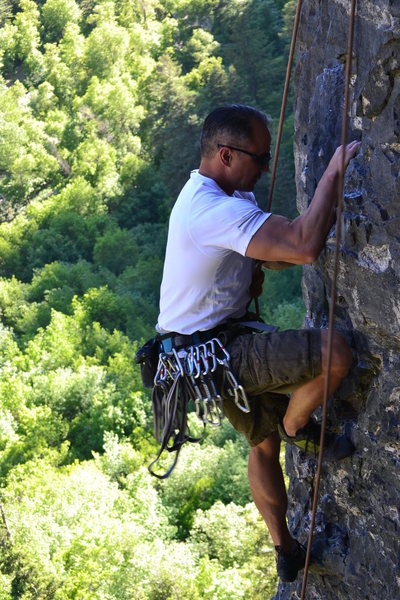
[157,105,358,581]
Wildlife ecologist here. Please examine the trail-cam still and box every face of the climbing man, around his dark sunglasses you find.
[231,121,271,192]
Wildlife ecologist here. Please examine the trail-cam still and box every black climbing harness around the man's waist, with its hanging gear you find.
[135,315,278,479]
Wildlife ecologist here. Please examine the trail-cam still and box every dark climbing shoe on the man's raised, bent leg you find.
[278,419,354,460]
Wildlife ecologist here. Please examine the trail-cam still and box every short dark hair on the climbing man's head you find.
[200,104,268,157]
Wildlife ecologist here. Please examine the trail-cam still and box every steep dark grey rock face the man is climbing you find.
[275,0,400,600]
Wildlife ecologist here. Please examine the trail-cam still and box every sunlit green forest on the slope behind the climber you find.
[0,0,304,600]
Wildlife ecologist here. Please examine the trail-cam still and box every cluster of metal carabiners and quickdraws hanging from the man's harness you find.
[149,337,250,479]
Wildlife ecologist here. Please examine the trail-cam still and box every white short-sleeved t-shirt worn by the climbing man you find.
[156,171,270,334]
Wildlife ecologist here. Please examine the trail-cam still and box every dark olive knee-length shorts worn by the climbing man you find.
[223,329,322,446]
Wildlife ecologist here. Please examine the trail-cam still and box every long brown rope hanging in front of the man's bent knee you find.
[301,0,357,600]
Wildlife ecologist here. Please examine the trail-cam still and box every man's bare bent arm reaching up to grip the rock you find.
[246,142,360,264]
